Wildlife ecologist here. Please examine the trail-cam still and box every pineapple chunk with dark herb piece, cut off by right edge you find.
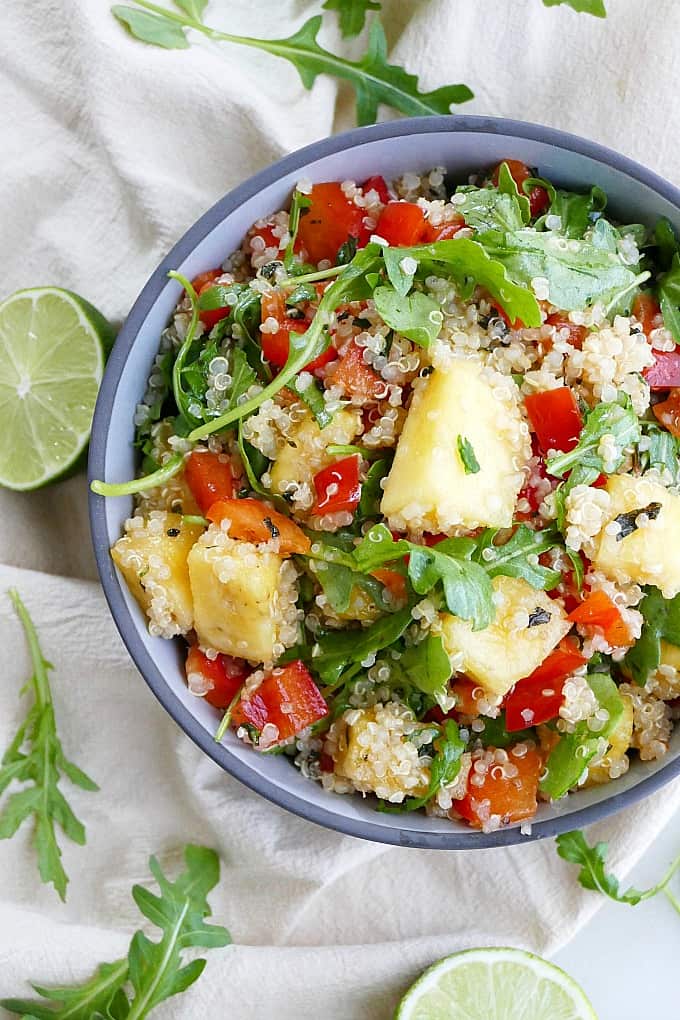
[592,474,680,599]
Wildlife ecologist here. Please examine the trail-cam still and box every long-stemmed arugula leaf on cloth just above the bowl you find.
[111,0,473,124]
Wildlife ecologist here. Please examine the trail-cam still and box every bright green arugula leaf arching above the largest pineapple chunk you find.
[382,235,541,326]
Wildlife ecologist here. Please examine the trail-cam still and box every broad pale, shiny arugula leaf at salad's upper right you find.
[478,230,648,311]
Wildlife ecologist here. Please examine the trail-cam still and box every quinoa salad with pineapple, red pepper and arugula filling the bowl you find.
[93,153,680,832]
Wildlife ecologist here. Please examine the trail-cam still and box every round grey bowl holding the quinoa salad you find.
[89,116,680,850]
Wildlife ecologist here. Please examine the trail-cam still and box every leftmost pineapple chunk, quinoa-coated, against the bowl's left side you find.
[111,510,203,638]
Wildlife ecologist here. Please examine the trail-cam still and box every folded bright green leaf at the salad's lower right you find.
[538,673,623,801]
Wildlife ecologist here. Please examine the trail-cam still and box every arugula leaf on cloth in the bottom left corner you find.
[0,845,231,1020]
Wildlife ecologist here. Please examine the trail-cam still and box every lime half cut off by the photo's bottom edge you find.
[395,949,597,1020]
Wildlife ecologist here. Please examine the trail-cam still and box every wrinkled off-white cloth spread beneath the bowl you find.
[0,0,680,1020]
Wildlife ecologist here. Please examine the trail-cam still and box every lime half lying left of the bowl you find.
[0,287,113,491]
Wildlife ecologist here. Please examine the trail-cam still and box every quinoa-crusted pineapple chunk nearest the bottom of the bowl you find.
[334,702,430,804]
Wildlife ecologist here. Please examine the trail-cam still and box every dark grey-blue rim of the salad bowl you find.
[88,114,680,850]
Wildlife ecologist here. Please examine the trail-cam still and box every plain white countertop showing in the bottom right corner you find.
[554,814,680,1020]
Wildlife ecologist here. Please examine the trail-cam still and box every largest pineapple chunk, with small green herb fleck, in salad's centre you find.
[381,360,531,534]
